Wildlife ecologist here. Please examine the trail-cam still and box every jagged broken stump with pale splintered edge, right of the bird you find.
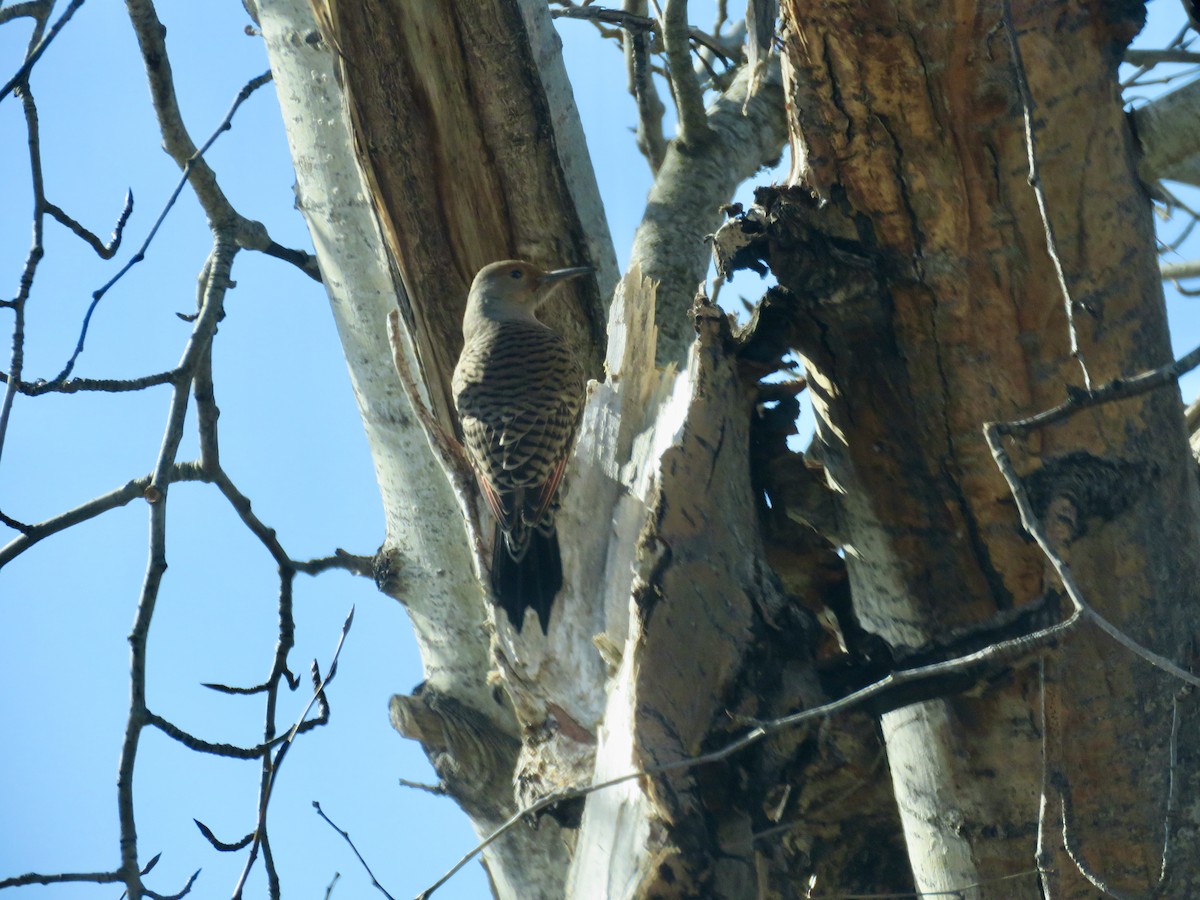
[568,271,911,898]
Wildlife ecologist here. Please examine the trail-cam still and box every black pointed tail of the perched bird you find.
[492,526,563,635]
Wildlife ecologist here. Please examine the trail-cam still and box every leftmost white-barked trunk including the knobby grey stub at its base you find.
[258,0,578,898]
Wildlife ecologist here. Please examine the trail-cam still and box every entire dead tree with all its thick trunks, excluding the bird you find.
[259,0,1200,898]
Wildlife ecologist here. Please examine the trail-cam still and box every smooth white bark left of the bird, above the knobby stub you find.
[258,0,494,710]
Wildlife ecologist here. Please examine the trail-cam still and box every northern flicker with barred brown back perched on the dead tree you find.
[451,259,592,634]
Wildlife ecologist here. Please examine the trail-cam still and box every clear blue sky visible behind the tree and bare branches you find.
[0,0,1200,900]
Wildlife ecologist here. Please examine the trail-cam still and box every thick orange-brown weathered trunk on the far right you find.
[734,0,1200,898]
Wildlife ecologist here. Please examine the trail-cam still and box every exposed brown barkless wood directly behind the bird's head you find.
[316,0,616,427]
